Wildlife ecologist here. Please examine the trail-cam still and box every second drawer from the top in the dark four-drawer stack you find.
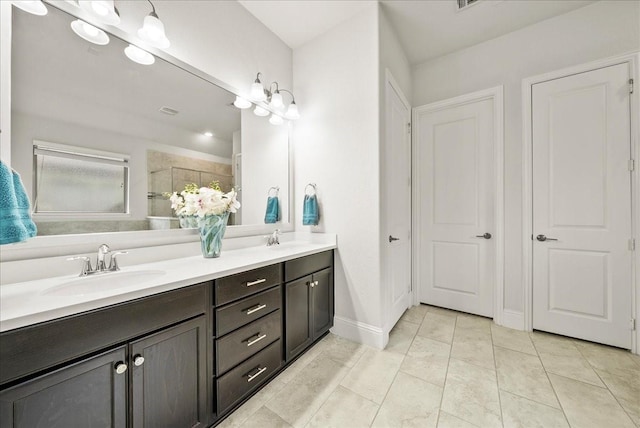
[216,286,282,337]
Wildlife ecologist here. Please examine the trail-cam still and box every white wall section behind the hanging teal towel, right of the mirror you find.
[293,2,382,346]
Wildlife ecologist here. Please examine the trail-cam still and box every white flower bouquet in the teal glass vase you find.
[169,182,240,218]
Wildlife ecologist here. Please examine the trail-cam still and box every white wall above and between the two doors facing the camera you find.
[413,0,640,311]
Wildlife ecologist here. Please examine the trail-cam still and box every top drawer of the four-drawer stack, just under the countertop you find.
[214,264,282,305]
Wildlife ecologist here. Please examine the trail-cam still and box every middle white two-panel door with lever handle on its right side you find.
[417,99,495,317]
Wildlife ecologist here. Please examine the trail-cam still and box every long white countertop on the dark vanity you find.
[0,235,336,331]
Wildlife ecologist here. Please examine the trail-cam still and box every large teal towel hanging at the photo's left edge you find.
[0,161,38,245]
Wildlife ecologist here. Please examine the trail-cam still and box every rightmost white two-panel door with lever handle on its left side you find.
[532,64,632,348]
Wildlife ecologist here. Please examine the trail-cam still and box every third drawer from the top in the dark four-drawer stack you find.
[216,311,282,376]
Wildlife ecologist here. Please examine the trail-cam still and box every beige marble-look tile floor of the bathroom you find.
[219,305,640,428]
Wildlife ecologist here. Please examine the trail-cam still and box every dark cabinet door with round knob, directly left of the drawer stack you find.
[130,316,208,428]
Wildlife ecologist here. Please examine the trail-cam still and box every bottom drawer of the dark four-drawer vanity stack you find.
[218,340,282,414]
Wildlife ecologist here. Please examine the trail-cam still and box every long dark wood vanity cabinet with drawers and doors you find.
[0,245,335,428]
